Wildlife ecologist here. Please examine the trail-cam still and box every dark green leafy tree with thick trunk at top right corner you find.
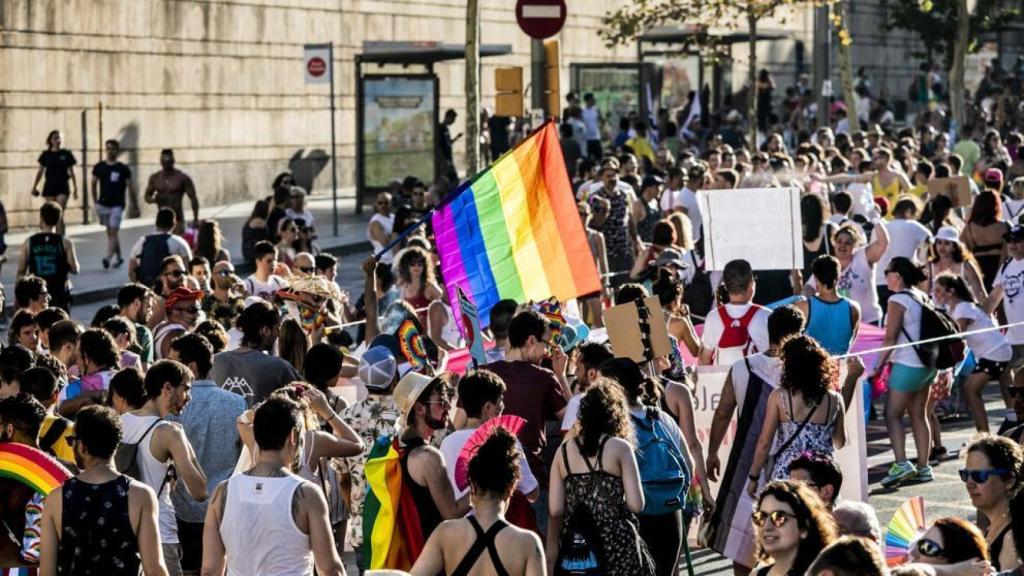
[882,0,1021,129]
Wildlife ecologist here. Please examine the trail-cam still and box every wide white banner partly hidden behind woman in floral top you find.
[693,366,867,502]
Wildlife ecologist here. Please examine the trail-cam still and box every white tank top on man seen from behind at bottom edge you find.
[219,475,313,576]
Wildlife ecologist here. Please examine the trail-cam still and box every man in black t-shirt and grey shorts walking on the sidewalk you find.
[92,139,138,269]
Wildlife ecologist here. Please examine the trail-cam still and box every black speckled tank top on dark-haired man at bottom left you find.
[57,476,141,576]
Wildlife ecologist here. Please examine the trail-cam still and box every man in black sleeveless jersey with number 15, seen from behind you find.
[17,202,79,313]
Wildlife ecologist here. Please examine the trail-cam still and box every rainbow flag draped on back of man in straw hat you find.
[362,436,426,570]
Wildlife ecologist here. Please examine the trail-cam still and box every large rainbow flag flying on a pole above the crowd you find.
[432,122,601,329]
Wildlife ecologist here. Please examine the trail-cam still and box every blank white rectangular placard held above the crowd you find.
[697,188,804,271]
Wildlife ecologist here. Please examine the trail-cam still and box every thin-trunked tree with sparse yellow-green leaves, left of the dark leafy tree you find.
[599,0,835,149]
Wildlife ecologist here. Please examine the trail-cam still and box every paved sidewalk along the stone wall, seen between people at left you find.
[0,191,370,305]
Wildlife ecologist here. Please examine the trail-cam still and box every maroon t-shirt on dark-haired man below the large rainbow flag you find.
[484,360,566,488]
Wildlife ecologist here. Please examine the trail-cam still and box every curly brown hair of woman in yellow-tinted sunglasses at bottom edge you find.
[758,480,836,576]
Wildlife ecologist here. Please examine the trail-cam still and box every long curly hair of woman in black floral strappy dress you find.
[577,378,633,457]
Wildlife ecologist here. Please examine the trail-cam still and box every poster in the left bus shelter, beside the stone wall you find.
[362,76,437,188]
